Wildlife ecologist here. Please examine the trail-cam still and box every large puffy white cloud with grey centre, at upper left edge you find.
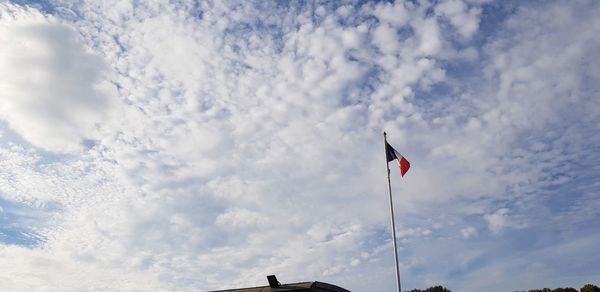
[0,3,112,152]
